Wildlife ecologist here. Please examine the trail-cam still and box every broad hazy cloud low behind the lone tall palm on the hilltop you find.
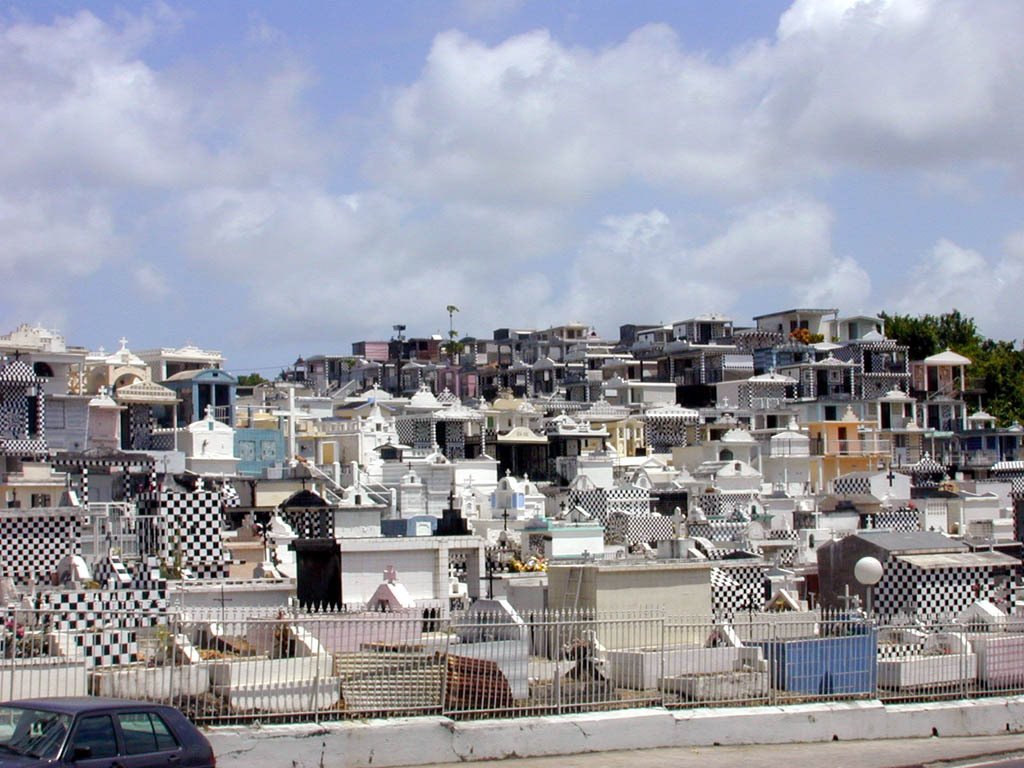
[179,184,560,337]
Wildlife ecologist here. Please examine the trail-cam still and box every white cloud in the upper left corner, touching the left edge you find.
[0,11,202,186]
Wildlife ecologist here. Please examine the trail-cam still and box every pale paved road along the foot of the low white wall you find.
[405,735,1024,768]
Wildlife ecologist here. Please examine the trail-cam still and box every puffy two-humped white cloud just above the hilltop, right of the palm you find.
[567,200,870,325]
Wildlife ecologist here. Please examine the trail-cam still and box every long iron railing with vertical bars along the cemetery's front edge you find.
[0,604,1024,724]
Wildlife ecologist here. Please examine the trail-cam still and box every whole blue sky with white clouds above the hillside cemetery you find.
[0,0,1024,373]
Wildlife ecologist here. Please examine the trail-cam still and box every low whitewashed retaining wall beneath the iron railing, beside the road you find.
[208,696,1024,768]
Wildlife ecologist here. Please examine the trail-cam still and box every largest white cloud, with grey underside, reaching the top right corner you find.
[370,0,1024,208]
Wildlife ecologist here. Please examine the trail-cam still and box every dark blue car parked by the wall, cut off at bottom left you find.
[0,696,217,768]
